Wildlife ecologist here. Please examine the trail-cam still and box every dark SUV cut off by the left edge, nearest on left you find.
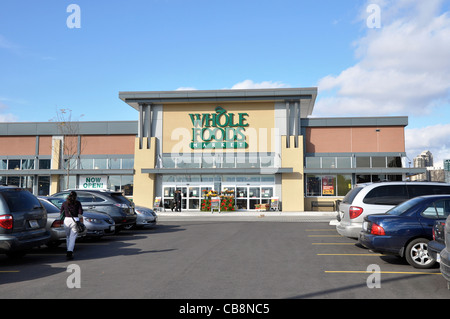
[0,186,50,257]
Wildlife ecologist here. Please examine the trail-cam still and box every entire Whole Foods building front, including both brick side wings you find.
[0,88,422,211]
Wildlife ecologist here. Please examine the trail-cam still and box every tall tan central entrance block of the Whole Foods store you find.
[119,88,317,211]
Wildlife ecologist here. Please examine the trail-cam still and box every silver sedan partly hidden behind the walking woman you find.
[39,196,115,247]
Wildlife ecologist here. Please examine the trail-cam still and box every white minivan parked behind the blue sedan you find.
[336,182,450,238]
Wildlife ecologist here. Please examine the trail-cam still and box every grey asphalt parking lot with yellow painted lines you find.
[0,217,450,299]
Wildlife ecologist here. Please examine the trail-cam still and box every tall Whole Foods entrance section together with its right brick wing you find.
[119,88,418,211]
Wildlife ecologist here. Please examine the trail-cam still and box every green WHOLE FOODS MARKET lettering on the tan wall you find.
[189,106,248,149]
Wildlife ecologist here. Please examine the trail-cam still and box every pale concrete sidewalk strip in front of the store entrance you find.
[156,210,337,222]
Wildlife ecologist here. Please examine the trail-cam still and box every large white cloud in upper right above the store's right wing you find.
[315,0,450,115]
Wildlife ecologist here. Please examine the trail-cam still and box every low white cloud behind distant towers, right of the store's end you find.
[405,124,450,167]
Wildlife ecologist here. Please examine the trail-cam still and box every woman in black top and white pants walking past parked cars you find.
[61,191,83,259]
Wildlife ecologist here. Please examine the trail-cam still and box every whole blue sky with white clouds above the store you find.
[0,0,450,168]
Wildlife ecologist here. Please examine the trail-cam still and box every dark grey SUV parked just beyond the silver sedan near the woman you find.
[52,189,137,233]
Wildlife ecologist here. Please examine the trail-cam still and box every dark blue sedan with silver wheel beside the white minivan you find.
[358,195,450,269]
